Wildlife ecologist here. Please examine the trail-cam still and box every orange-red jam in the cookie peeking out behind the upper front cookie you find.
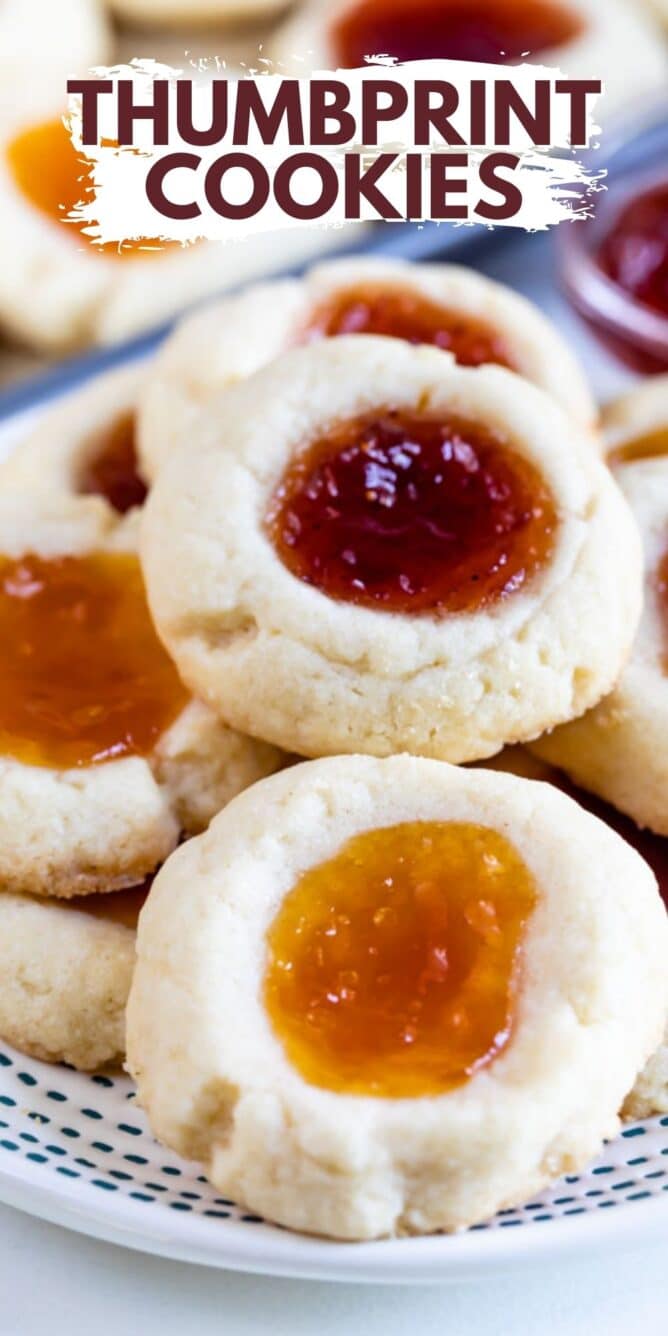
[303,283,516,370]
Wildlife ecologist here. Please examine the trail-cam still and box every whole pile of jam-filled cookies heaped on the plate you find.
[0,259,668,1238]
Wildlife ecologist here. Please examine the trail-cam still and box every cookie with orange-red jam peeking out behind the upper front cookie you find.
[139,255,597,477]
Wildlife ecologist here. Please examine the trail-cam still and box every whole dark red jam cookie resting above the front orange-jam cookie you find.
[142,334,641,762]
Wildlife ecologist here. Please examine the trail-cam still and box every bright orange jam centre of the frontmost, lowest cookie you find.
[265,822,537,1098]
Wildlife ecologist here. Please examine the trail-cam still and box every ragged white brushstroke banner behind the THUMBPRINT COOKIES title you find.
[65,59,605,244]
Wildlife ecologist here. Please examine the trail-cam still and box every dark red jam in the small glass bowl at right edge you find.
[597,182,668,323]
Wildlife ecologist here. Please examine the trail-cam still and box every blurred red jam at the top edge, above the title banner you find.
[331,0,584,69]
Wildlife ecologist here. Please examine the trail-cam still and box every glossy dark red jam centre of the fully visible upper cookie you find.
[266,410,557,613]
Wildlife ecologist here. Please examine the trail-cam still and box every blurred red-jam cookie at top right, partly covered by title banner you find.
[270,0,668,115]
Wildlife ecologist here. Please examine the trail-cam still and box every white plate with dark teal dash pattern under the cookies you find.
[0,1045,668,1281]
